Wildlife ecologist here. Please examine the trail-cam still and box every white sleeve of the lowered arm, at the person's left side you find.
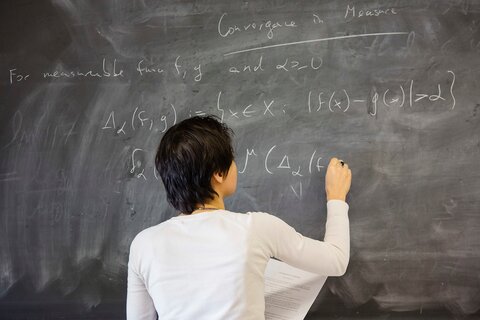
[127,240,157,320]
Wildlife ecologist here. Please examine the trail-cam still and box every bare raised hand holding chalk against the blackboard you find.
[325,158,352,201]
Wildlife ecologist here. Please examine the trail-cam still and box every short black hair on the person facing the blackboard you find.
[155,115,234,214]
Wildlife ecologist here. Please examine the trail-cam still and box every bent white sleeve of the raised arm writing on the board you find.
[254,200,350,276]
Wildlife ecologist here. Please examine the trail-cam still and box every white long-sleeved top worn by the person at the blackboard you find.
[127,200,350,320]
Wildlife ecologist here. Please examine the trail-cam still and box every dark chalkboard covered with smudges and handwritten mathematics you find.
[0,0,480,319]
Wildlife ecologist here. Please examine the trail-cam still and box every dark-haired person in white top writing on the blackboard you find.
[127,116,351,320]
